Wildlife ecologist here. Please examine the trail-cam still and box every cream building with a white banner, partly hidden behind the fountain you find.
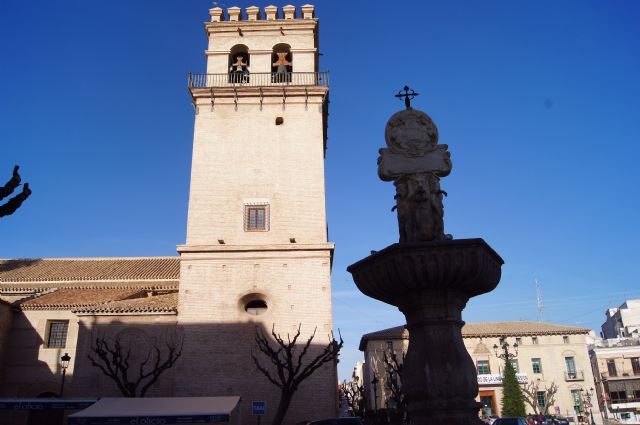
[360,322,602,424]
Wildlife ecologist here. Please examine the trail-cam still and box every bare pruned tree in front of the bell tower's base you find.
[251,325,343,425]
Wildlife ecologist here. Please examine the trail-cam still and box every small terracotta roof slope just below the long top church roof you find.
[20,288,146,310]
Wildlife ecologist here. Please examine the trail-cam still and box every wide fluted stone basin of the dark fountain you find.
[347,238,504,306]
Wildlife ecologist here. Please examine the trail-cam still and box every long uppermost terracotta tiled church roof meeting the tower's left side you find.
[0,257,180,286]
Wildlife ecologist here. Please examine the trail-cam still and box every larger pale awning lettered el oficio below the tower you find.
[69,396,240,425]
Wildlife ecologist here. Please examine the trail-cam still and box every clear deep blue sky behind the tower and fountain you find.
[0,0,640,379]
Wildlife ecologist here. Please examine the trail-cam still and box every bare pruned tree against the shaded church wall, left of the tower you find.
[88,337,184,397]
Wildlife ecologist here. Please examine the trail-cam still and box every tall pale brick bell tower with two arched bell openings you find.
[175,5,337,423]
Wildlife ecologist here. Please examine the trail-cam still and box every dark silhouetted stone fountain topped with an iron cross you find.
[347,87,504,425]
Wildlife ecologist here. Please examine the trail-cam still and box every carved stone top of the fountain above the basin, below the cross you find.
[378,109,452,242]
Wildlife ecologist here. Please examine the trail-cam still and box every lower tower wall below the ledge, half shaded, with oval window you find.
[175,247,337,424]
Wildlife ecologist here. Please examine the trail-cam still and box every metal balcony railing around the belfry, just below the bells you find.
[189,71,329,88]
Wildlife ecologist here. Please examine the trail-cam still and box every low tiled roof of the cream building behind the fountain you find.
[359,321,591,351]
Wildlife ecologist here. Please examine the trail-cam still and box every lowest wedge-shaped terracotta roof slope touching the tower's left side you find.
[72,292,178,314]
